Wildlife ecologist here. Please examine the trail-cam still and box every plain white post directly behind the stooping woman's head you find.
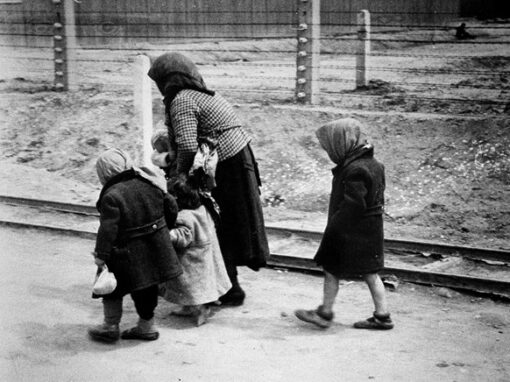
[134,54,153,167]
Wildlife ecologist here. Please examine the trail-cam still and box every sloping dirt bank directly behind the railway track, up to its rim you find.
[0,86,510,248]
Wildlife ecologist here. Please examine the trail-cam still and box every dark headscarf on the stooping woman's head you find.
[147,53,214,105]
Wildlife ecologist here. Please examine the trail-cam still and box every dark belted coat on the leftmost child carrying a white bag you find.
[95,169,182,297]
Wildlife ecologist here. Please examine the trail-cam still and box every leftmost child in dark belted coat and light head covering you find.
[89,149,182,342]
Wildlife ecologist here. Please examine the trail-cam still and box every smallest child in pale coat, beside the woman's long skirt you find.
[161,175,232,326]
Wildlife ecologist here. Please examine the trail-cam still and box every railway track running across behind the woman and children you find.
[0,196,510,299]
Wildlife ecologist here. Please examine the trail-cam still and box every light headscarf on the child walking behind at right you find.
[315,118,372,166]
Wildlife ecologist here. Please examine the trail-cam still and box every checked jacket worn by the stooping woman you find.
[165,89,250,173]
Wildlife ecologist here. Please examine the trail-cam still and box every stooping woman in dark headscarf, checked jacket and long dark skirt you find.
[148,53,269,306]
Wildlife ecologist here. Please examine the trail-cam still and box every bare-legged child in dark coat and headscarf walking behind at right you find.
[295,118,393,329]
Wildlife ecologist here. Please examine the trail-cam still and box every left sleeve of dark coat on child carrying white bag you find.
[94,195,120,260]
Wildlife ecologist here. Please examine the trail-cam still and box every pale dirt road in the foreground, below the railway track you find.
[0,227,510,382]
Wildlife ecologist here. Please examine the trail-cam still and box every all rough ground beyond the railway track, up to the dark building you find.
[0,20,510,248]
